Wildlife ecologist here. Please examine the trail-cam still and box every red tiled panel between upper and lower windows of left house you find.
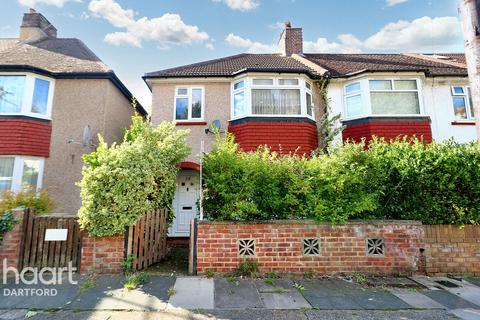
[0,119,52,157]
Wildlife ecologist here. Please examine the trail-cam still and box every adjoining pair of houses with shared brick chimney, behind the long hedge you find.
[144,23,476,237]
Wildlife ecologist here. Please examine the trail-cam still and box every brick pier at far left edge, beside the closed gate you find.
[0,209,25,271]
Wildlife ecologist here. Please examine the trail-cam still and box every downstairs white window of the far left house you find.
[0,156,44,193]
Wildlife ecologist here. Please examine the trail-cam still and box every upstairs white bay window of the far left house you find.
[0,73,55,119]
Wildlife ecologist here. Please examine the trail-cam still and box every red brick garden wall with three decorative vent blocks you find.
[197,221,423,274]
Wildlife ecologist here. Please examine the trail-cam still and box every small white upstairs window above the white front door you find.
[173,86,205,121]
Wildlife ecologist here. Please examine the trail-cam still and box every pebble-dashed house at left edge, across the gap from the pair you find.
[0,9,146,214]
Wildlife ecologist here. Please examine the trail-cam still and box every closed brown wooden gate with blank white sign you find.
[18,210,82,270]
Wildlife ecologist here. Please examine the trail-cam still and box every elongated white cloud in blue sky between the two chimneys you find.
[88,0,210,48]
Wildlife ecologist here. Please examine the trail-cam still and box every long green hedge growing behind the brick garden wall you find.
[203,135,480,224]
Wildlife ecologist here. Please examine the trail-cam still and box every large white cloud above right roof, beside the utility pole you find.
[364,17,462,52]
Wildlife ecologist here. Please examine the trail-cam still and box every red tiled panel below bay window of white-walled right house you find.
[342,121,432,143]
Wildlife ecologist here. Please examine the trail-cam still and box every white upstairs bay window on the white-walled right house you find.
[344,78,423,118]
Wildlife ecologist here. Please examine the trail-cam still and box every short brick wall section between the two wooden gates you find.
[80,232,125,273]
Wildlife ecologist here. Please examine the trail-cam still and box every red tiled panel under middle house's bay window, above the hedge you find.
[228,122,318,154]
